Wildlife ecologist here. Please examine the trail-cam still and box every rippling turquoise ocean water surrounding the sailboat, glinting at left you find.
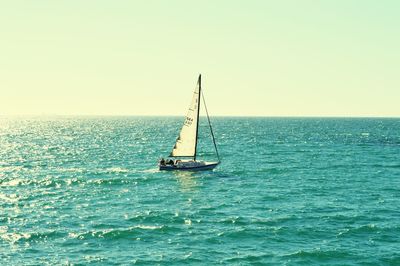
[0,117,400,265]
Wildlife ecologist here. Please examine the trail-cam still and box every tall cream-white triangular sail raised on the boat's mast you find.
[170,77,201,157]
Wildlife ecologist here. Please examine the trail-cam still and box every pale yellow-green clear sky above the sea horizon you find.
[0,0,400,117]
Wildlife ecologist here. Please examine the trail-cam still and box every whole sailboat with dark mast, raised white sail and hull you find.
[159,74,220,171]
